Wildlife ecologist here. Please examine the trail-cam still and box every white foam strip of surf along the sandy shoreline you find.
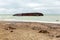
[0,19,60,24]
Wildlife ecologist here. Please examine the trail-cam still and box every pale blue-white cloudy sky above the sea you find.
[0,0,60,14]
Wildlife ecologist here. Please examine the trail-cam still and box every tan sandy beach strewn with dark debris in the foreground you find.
[0,21,60,40]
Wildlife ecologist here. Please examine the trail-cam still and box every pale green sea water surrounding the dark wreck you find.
[0,14,60,22]
